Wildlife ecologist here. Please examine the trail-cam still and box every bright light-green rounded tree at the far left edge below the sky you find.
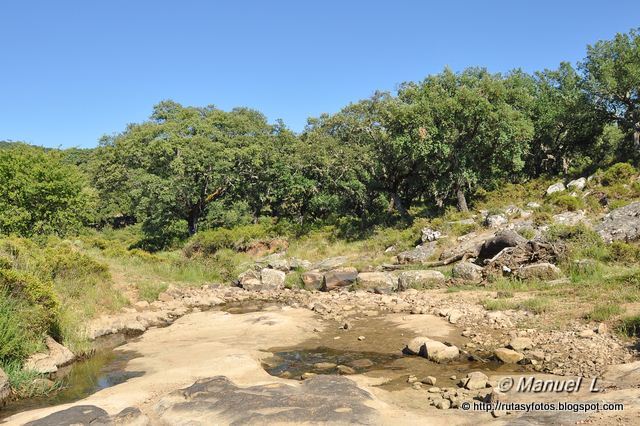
[0,144,95,236]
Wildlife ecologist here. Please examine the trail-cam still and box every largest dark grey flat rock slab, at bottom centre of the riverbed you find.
[156,375,377,425]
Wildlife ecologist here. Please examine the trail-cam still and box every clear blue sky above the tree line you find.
[0,0,640,147]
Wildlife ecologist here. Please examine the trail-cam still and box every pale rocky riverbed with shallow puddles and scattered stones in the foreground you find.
[5,286,640,424]
